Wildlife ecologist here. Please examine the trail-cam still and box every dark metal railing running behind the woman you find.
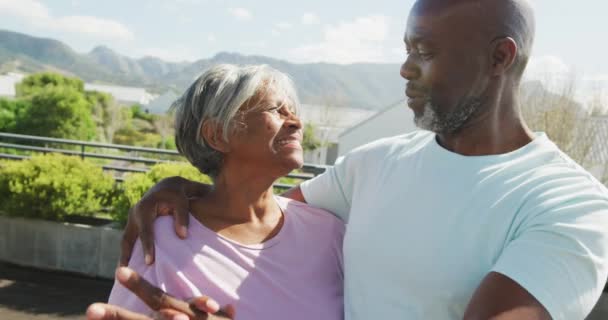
[0,132,327,189]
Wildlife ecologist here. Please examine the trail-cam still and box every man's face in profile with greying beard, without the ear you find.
[401,1,489,134]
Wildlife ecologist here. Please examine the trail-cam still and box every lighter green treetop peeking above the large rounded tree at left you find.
[16,72,84,97]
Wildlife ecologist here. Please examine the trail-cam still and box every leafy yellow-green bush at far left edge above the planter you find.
[0,154,114,221]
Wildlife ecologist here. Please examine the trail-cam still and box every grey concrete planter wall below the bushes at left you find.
[0,216,122,279]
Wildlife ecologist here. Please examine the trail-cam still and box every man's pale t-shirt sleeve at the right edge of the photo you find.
[492,185,608,320]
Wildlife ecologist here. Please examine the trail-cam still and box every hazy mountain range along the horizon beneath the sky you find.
[0,30,405,109]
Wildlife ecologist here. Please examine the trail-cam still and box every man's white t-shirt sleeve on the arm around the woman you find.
[300,155,353,222]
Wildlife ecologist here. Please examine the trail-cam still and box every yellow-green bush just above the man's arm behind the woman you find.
[112,163,211,225]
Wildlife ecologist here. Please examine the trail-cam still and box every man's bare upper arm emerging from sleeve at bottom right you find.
[464,272,551,320]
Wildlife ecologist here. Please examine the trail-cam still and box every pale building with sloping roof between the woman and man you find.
[338,100,416,156]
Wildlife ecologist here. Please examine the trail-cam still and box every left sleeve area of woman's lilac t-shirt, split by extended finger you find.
[108,240,158,316]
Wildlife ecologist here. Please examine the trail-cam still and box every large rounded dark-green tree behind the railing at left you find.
[17,86,96,140]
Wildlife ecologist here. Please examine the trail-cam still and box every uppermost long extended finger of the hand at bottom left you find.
[116,267,198,318]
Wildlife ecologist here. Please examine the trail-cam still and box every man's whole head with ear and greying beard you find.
[401,0,534,135]
